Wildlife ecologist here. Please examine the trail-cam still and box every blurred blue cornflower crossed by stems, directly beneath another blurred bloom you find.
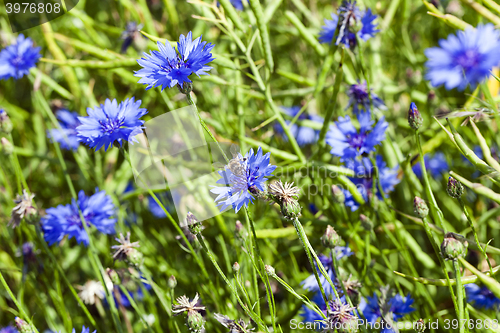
[343,155,400,212]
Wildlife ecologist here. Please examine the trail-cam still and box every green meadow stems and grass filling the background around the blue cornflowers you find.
[0,0,500,333]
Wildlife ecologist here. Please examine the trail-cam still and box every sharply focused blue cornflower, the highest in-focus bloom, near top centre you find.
[135,31,214,91]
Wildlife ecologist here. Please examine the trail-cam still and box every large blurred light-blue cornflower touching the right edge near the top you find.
[425,24,500,90]
